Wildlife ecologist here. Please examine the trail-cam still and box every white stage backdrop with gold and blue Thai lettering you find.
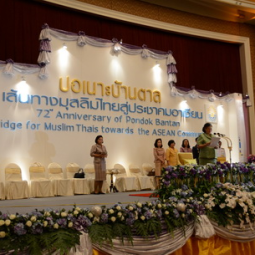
[0,30,246,180]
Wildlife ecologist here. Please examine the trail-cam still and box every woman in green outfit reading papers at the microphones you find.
[197,123,218,165]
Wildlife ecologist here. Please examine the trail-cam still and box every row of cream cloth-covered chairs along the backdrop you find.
[0,162,155,200]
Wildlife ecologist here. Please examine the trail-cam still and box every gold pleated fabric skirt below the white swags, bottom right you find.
[93,236,255,255]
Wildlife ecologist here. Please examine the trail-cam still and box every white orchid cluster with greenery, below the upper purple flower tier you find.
[157,182,255,230]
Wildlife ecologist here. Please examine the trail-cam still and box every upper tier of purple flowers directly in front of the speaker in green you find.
[157,163,255,199]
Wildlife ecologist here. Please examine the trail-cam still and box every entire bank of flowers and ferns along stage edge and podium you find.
[0,163,255,255]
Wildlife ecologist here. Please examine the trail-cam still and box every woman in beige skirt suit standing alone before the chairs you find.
[90,135,107,194]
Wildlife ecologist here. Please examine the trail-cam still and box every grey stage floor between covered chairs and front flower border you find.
[0,190,155,214]
